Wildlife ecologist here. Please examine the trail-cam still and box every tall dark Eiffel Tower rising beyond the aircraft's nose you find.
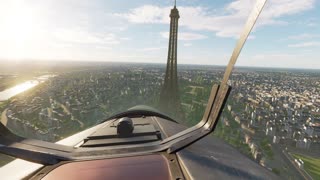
[160,1,183,119]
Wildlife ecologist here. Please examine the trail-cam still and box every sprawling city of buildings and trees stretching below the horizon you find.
[0,64,320,179]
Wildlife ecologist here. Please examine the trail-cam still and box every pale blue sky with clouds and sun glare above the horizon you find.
[0,0,320,69]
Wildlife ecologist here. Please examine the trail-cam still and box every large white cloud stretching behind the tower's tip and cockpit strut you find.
[114,0,315,37]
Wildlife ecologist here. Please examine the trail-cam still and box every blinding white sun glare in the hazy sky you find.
[0,0,38,59]
